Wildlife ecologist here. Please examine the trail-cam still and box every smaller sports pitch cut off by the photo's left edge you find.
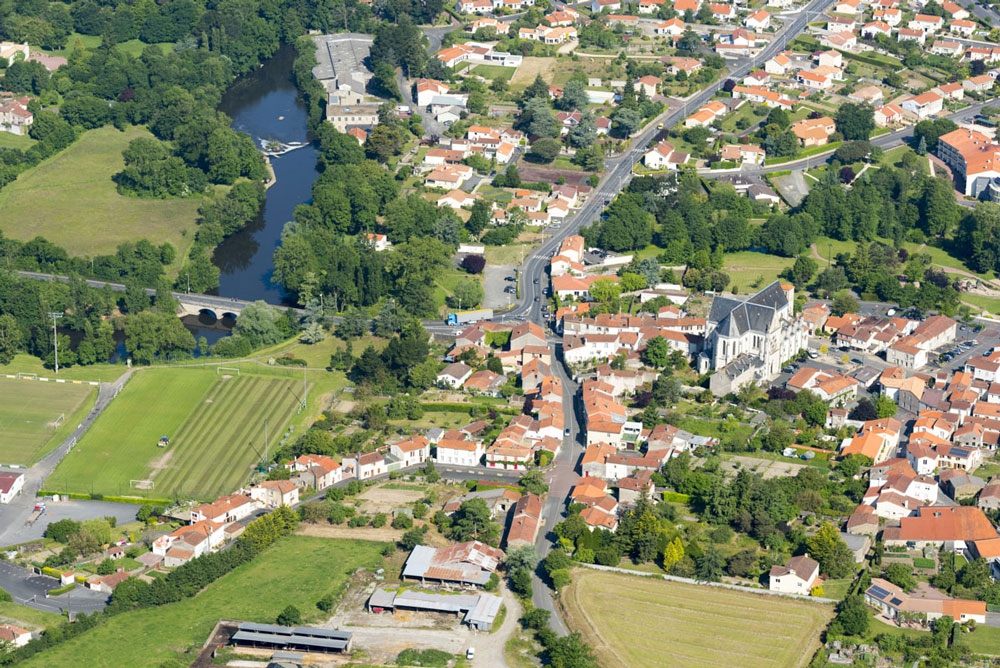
[0,378,97,466]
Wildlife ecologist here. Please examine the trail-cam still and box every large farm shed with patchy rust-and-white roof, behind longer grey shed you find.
[403,540,504,587]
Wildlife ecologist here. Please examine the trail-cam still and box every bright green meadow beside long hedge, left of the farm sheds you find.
[23,536,382,668]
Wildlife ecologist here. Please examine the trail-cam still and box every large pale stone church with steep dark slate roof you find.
[699,281,808,396]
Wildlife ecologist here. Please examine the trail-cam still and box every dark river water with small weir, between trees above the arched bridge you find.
[213,46,318,304]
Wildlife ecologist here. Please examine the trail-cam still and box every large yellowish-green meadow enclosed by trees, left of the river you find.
[0,126,202,272]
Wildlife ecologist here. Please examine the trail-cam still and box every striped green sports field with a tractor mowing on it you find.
[47,368,302,499]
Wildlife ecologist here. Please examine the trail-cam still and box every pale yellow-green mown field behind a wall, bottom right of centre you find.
[559,569,833,668]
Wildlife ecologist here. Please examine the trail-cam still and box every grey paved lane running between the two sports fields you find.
[0,369,134,545]
